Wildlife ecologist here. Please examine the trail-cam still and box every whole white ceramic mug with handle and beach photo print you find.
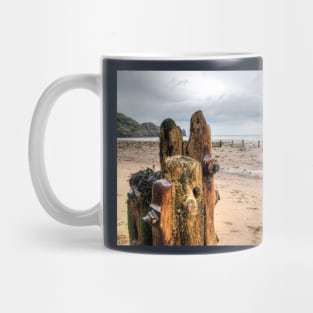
[29,53,263,253]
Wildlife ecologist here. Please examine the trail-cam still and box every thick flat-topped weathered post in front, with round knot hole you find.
[161,156,204,246]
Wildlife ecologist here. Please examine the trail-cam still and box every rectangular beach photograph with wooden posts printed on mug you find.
[116,70,263,246]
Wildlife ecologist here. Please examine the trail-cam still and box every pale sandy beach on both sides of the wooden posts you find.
[117,141,263,245]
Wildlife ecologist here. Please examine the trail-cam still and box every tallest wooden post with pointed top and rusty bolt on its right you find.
[186,111,219,245]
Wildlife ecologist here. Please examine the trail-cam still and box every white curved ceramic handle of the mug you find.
[28,74,101,226]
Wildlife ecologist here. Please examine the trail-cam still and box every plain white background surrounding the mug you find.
[0,0,313,313]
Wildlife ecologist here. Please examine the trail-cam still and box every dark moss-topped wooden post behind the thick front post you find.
[160,118,183,171]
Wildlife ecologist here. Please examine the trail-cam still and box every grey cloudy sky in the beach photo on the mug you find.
[117,71,262,135]
